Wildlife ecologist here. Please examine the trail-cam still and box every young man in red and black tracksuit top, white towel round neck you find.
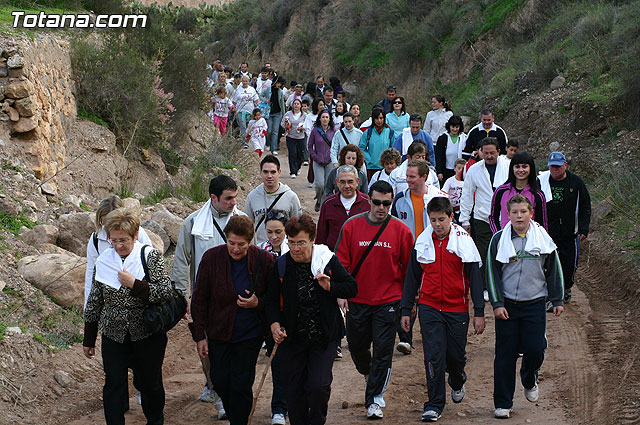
[400,197,485,422]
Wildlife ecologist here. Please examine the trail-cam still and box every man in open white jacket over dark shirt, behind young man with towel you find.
[460,137,509,301]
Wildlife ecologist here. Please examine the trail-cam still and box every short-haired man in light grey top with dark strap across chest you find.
[244,155,302,244]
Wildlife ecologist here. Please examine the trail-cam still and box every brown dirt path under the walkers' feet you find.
[0,141,640,425]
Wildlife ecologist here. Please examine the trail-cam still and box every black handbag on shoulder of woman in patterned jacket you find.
[140,245,187,335]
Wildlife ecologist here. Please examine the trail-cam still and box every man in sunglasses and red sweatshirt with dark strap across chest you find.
[336,180,413,419]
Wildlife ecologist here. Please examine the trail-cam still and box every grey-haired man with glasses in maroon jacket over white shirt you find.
[316,165,369,251]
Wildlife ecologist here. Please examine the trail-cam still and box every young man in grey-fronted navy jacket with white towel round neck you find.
[487,195,564,418]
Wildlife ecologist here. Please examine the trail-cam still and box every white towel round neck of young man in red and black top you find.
[414,223,482,266]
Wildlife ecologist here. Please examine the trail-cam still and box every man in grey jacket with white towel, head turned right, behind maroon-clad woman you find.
[171,174,246,419]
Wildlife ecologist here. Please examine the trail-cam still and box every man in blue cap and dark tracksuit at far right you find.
[547,152,591,309]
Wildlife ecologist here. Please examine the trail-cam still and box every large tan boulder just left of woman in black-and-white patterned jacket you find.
[18,254,87,307]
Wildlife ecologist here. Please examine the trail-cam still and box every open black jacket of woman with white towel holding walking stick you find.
[265,253,358,343]
